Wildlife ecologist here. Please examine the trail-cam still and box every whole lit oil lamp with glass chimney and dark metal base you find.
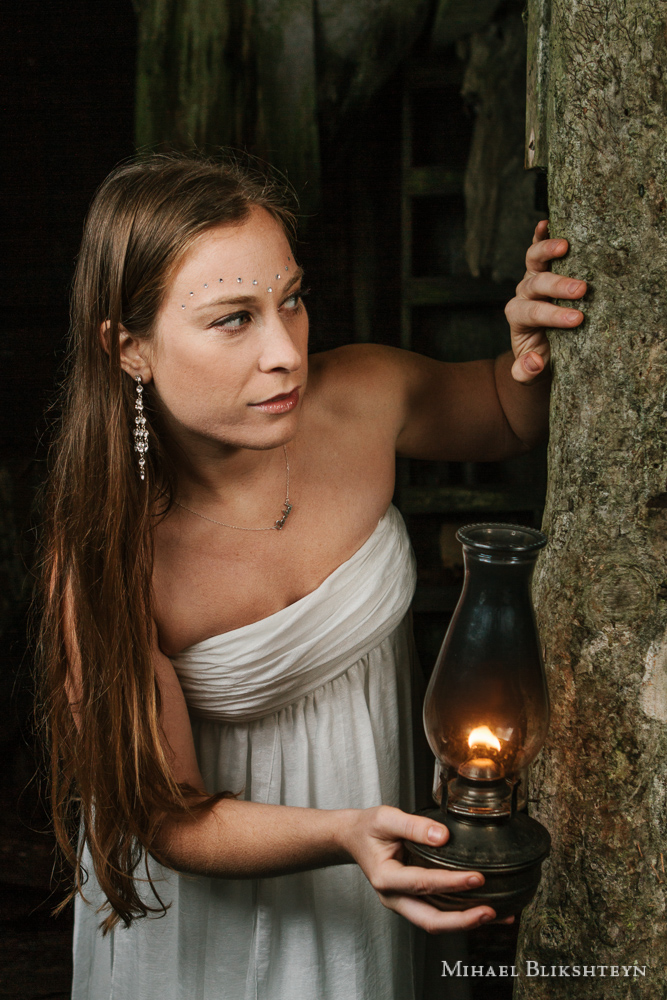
[405,524,551,918]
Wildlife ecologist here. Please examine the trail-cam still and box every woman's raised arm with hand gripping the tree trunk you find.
[331,222,586,462]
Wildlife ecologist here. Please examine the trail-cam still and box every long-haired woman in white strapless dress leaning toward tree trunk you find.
[41,157,585,1000]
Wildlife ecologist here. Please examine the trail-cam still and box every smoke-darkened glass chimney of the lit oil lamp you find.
[424,524,549,780]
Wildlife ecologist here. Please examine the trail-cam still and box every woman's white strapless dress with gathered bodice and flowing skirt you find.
[72,507,418,1000]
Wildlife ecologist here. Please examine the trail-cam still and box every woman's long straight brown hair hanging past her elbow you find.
[37,156,294,932]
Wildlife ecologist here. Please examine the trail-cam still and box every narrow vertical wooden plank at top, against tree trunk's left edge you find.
[525,0,551,170]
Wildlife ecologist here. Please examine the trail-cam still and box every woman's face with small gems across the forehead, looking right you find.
[142,206,308,449]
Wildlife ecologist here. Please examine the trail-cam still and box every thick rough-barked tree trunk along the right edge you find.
[515,0,667,1000]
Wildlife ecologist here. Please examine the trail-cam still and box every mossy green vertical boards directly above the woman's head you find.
[136,0,320,211]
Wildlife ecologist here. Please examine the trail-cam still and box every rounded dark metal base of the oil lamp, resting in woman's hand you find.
[405,809,551,920]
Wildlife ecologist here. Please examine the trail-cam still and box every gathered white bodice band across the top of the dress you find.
[172,506,416,722]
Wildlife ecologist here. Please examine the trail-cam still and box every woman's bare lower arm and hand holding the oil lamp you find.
[155,642,506,933]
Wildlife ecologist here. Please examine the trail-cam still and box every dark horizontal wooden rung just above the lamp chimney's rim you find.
[400,485,544,520]
